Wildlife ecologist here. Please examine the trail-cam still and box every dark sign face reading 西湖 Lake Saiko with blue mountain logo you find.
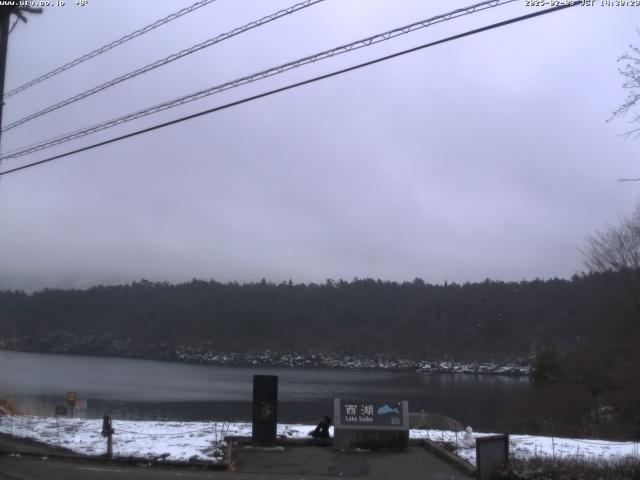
[336,399,404,428]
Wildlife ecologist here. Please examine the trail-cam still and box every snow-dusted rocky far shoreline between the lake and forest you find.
[0,331,531,376]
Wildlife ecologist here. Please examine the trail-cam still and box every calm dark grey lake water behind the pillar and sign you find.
[0,352,531,431]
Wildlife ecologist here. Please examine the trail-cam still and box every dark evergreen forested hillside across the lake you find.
[0,275,603,360]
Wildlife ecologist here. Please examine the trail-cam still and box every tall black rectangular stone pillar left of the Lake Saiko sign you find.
[251,375,278,446]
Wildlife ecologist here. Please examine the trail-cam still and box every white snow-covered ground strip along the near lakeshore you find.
[0,416,640,464]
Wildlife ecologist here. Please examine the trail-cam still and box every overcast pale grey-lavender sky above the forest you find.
[0,0,640,288]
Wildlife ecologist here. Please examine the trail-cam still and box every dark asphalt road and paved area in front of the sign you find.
[0,437,470,480]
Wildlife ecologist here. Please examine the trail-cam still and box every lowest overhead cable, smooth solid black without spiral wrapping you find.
[0,2,579,176]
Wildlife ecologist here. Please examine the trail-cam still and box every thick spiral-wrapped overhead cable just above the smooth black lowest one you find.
[0,0,516,161]
